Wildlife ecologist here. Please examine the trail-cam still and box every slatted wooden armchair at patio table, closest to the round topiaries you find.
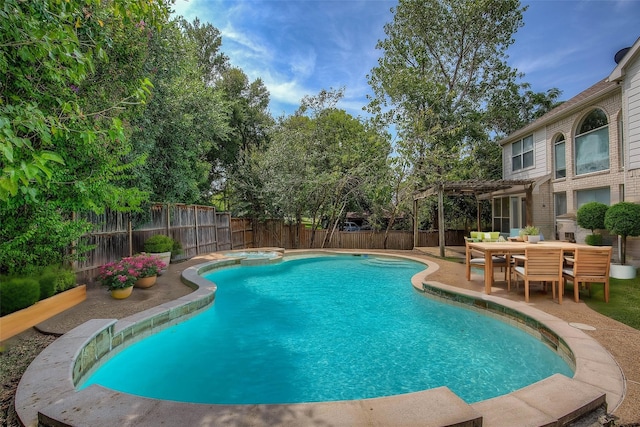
[561,246,611,302]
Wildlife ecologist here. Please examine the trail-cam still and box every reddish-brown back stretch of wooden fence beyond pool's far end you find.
[253,220,465,250]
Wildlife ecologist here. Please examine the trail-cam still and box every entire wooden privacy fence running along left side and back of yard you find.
[75,211,465,283]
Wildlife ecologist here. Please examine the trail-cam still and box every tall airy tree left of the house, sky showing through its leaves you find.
[367,0,524,189]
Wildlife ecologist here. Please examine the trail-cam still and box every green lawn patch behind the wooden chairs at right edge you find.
[565,276,640,330]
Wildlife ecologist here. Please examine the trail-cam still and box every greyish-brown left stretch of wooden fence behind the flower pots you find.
[75,203,253,282]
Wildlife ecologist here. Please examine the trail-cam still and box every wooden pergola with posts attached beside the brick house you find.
[413,179,536,257]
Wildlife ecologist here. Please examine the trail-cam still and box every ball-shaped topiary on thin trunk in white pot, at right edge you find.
[604,202,640,279]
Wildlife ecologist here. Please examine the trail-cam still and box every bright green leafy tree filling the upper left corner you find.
[0,0,169,273]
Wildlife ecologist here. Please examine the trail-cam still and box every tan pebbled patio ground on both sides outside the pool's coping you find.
[0,248,640,427]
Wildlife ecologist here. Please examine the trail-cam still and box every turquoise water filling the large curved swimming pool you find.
[77,256,573,404]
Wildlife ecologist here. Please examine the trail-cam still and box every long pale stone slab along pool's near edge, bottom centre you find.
[38,385,482,427]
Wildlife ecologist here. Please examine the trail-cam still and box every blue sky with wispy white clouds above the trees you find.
[174,0,640,117]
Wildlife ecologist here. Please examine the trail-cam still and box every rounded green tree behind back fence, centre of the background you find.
[234,90,390,247]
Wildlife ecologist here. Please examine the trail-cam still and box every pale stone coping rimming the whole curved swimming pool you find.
[16,249,625,426]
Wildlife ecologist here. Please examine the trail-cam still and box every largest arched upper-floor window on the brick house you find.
[575,109,609,175]
